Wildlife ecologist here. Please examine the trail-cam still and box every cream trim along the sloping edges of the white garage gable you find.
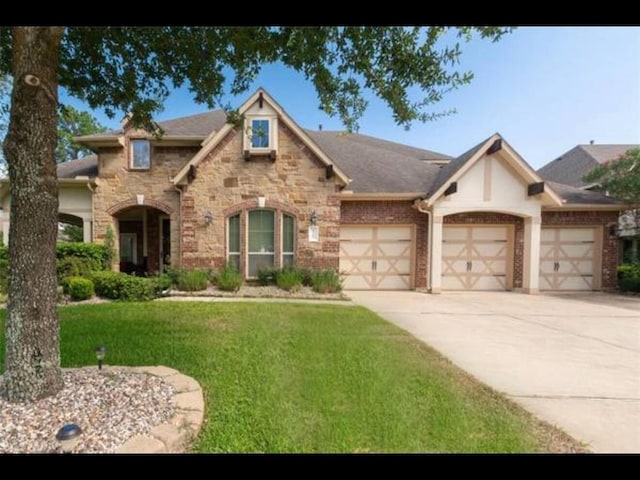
[426,133,562,206]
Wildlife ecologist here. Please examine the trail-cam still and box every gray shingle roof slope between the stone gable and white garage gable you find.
[306,130,451,195]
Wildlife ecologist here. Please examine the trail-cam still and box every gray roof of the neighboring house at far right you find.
[538,144,640,188]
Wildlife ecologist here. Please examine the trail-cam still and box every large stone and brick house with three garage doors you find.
[0,89,622,293]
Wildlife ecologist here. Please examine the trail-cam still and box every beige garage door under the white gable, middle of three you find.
[442,225,512,290]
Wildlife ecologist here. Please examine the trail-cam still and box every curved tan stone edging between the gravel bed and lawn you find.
[105,365,204,453]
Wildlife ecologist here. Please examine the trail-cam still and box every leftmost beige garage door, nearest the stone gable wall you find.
[340,225,413,290]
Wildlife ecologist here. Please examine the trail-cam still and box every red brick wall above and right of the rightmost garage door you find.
[542,212,618,291]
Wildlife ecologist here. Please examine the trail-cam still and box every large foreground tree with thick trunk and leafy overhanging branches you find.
[0,27,509,401]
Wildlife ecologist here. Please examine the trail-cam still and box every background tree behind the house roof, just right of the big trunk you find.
[56,105,106,163]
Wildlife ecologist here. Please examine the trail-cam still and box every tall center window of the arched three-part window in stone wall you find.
[247,210,275,277]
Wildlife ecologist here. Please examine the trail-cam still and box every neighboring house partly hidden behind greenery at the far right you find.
[538,143,640,260]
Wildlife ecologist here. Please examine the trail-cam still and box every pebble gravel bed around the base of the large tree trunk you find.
[0,367,175,453]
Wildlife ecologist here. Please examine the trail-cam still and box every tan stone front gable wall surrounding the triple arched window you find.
[181,122,340,269]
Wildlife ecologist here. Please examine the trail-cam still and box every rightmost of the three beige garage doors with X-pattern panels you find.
[540,227,600,290]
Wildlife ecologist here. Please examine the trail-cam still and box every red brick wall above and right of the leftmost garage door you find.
[340,201,429,289]
